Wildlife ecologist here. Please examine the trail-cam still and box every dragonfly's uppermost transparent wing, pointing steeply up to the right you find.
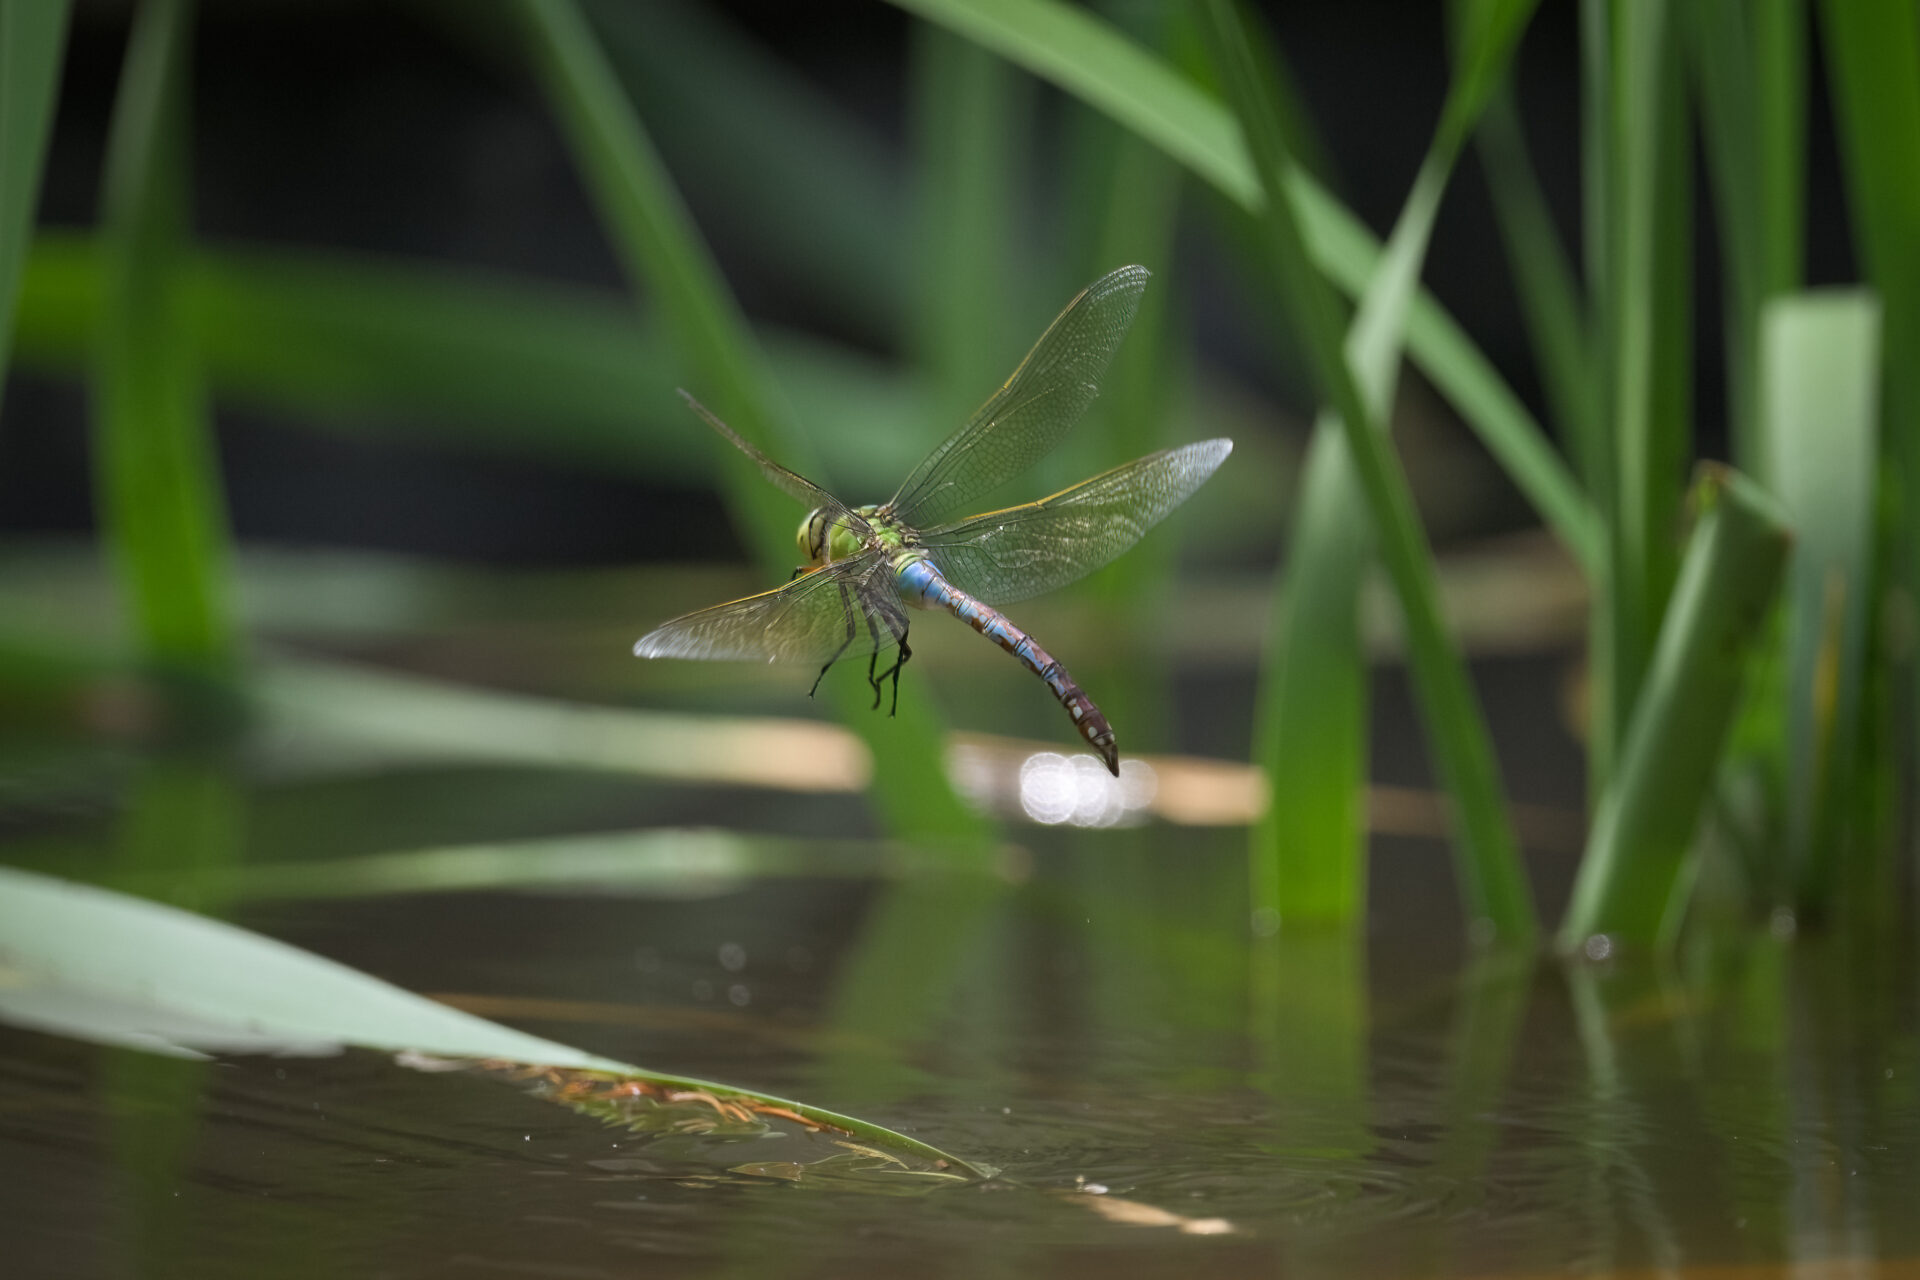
[887,267,1150,526]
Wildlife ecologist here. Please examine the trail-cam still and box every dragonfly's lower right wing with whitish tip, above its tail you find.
[920,439,1233,604]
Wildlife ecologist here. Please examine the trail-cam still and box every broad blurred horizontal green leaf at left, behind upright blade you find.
[17,232,924,487]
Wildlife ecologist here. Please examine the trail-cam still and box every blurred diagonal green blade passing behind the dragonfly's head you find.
[518,0,991,856]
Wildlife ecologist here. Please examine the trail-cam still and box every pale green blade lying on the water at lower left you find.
[0,867,983,1176]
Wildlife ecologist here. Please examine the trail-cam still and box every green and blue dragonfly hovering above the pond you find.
[634,267,1233,777]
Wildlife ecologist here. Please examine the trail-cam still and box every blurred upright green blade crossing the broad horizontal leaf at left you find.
[94,0,236,674]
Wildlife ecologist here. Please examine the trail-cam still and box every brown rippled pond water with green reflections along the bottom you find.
[0,796,1920,1278]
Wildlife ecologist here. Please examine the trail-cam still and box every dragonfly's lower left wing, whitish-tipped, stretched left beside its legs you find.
[634,549,904,664]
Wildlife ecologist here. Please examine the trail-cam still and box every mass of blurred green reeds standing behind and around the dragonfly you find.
[0,0,1920,959]
